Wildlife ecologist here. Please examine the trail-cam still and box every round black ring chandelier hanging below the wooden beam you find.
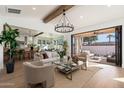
[55,9,74,33]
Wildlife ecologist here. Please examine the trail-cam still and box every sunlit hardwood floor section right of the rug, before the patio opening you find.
[83,64,124,88]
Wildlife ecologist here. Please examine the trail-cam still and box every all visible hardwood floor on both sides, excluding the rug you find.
[0,62,124,88]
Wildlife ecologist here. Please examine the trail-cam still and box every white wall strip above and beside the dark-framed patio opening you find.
[66,18,124,68]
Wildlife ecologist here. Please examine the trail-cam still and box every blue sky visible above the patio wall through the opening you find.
[96,33,115,42]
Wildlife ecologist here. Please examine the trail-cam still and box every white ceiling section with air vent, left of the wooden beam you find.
[0,5,58,19]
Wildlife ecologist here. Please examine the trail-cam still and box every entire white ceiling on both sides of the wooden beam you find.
[0,5,124,29]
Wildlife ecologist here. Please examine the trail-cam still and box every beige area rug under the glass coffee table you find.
[54,67,102,88]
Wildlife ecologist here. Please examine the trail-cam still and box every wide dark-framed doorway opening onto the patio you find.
[71,26,122,67]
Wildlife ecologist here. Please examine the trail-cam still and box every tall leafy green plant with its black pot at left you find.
[0,23,19,73]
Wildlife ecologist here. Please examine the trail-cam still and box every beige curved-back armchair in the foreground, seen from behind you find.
[23,62,54,87]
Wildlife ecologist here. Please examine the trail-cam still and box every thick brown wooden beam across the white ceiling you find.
[43,5,74,23]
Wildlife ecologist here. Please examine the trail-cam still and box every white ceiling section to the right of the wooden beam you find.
[51,5,124,29]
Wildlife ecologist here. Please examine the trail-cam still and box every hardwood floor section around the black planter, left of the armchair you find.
[0,62,28,88]
